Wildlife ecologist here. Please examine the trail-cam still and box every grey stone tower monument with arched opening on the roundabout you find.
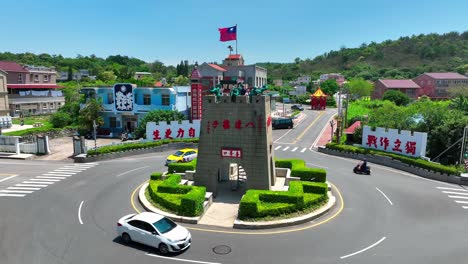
[195,94,276,196]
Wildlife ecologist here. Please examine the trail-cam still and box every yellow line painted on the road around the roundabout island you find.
[130,183,344,235]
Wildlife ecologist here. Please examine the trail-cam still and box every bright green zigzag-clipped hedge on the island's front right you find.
[239,181,328,219]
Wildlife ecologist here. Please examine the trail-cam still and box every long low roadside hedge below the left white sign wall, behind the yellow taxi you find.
[87,138,198,156]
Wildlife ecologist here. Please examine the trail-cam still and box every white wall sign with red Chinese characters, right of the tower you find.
[362,126,427,157]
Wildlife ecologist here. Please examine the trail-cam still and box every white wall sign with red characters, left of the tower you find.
[146,120,200,141]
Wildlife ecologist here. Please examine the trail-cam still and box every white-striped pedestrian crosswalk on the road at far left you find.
[0,163,98,197]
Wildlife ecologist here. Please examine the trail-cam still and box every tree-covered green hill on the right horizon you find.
[258,31,468,80]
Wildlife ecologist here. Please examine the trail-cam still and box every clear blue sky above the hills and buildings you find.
[0,0,468,65]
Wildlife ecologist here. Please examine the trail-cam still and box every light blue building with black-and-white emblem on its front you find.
[80,83,191,137]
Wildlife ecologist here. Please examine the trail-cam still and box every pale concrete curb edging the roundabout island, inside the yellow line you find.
[138,182,336,229]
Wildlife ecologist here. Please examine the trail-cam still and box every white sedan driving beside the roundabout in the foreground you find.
[117,212,192,254]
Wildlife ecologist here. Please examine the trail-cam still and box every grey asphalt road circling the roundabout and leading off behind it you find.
[0,106,468,264]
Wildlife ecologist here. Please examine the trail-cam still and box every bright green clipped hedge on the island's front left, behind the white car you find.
[148,173,206,216]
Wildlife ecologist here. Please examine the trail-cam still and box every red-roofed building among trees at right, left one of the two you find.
[372,79,421,99]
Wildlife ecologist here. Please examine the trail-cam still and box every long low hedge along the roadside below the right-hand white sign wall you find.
[326,143,460,175]
